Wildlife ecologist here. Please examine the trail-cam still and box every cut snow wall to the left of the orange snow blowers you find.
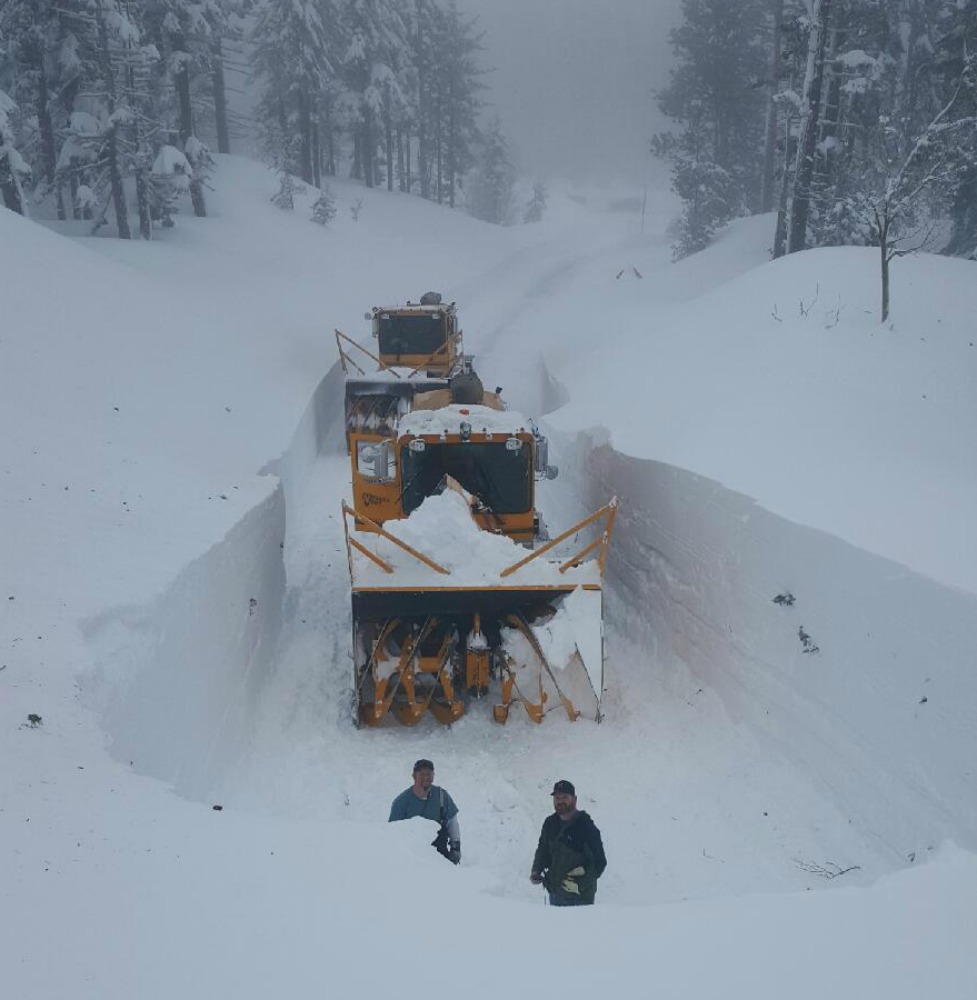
[79,364,343,800]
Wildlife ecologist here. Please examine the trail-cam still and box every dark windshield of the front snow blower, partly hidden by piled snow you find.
[400,441,532,514]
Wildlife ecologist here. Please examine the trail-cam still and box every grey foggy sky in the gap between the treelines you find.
[458,0,681,183]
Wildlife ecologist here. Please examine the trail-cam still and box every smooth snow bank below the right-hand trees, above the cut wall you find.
[536,241,977,593]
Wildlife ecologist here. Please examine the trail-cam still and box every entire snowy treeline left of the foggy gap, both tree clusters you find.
[0,0,513,232]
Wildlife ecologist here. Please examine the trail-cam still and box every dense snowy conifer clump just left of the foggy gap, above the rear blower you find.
[251,0,511,221]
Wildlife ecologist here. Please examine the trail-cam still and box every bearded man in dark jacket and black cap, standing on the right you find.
[529,781,607,906]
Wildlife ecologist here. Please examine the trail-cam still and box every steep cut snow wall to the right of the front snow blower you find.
[578,436,977,863]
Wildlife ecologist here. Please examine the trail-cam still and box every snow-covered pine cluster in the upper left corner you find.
[0,0,235,239]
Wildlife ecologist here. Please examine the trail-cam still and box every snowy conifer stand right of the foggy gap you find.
[652,0,977,278]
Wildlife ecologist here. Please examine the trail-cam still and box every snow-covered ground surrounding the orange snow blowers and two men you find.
[0,158,977,1000]
